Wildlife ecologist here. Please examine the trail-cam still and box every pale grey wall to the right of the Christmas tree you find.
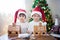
[47,0,60,18]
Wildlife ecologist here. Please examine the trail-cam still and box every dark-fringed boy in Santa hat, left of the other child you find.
[16,9,28,34]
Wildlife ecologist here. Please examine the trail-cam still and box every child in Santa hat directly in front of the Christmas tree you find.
[28,7,46,33]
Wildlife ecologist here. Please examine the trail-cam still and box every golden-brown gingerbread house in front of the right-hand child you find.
[33,23,46,37]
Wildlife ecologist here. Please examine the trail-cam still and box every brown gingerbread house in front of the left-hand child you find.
[8,24,21,38]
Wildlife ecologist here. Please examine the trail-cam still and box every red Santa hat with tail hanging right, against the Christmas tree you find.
[31,6,46,21]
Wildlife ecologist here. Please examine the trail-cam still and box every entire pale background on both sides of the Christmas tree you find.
[0,0,60,34]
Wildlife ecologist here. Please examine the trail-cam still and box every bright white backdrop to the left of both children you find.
[0,0,26,32]
